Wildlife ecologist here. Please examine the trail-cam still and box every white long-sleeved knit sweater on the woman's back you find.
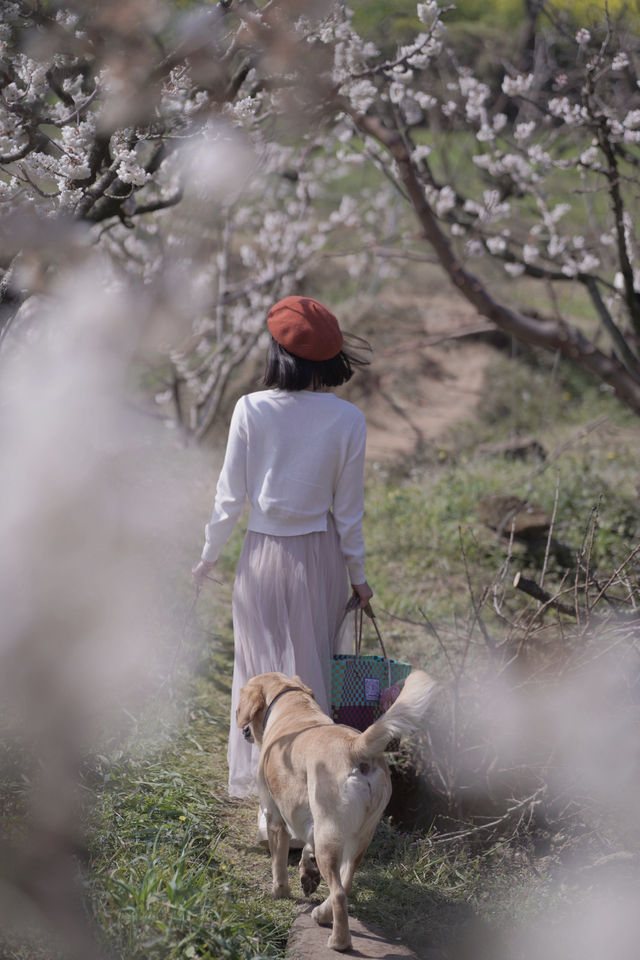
[202,390,366,583]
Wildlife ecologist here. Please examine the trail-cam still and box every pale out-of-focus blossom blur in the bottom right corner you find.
[426,632,640,960]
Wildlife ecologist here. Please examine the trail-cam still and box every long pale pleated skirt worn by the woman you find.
[227,514,350,797]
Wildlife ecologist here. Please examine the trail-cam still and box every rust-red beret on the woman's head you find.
[267,297,343,360]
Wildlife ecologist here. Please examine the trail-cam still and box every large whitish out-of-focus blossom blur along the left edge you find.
[0,260,188,960]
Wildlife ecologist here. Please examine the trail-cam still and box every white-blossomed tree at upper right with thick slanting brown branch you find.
[308,2,640,413]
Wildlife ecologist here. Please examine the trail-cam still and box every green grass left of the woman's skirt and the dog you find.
[81,616,294,960]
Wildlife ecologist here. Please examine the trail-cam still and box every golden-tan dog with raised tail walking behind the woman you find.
[236,670,436,950]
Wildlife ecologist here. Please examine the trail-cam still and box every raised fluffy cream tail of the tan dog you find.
[352,670,438,763]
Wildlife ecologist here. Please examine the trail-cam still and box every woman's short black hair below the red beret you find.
[262,333,371,390]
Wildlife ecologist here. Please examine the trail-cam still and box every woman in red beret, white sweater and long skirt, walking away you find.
[193,297,373,797]
